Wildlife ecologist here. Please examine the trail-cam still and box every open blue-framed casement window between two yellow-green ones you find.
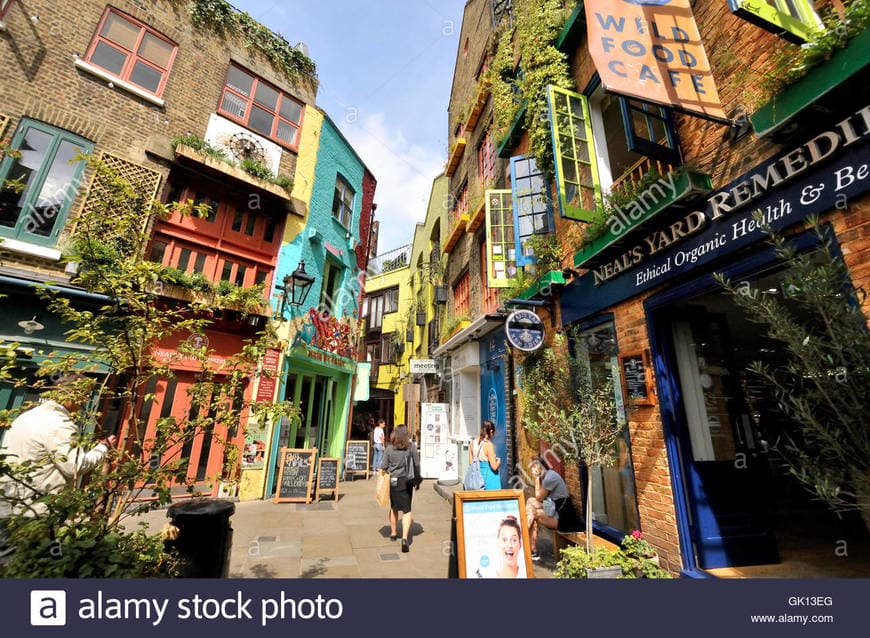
[511,155,555,266]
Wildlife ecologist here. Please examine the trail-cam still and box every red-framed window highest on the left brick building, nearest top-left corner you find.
[85,7,178,96]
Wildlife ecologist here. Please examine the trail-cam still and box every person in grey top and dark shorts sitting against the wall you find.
[526,458,583,560]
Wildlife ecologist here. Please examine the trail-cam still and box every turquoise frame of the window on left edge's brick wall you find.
[0,118,94,246]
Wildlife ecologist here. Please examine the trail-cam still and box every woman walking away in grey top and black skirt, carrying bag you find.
[380,425,422,552]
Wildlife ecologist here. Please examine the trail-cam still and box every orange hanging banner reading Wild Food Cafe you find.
[585,0,725,118]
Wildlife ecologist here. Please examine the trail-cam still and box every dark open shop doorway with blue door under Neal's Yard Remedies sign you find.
[651,262,867,576]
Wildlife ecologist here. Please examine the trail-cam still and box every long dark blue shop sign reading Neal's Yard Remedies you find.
[562,106,870,323]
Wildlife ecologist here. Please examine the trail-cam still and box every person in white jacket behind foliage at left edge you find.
[0,374,116,519]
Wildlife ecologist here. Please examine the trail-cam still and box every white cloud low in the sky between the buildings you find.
[339,112,446,253]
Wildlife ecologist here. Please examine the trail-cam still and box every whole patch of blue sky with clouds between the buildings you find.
[233,0,465,252]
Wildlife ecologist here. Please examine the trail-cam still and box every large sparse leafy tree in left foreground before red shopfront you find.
[0,158,298,578]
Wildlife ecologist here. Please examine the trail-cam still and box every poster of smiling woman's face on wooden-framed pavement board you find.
[460,498,529,578]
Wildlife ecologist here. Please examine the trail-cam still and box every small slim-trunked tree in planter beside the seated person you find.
[523,336,624,554]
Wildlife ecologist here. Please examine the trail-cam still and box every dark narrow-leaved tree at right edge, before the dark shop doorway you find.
[719,218,870,521]
